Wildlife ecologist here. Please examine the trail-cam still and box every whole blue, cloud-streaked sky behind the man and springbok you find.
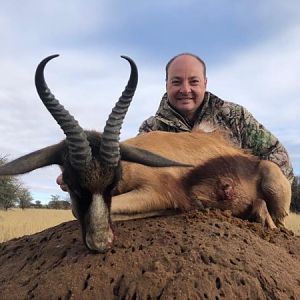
[0,0,300,203]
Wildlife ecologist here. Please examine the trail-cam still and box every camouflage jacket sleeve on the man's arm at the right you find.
[239,107,294,183]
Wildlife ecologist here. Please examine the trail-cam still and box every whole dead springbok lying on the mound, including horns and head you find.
[0,56,291,252]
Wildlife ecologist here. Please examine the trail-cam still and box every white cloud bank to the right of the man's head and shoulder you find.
[209,24,300,174]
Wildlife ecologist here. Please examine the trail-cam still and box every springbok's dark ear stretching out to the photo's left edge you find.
[0,142,64,176]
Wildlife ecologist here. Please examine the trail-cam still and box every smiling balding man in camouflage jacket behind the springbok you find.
[139,53,294,184]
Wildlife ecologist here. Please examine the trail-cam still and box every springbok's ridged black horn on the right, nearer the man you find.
[100,56,138,167]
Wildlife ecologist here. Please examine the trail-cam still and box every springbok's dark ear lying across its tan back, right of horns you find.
[120,143,193,167]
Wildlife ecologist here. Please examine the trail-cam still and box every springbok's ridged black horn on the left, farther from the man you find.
[35,55,92,171]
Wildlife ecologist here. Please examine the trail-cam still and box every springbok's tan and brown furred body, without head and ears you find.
[112,130,291,227]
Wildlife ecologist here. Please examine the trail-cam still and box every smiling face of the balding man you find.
[166,55,207,120]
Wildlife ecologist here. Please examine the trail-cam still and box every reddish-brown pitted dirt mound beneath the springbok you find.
[0,211,300,299]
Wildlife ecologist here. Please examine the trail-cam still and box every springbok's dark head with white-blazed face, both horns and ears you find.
[0,55,189,252]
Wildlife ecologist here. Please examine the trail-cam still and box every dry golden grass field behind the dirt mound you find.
[0,209,300,243]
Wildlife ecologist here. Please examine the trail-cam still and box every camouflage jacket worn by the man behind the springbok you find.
[139,92,294,183]
